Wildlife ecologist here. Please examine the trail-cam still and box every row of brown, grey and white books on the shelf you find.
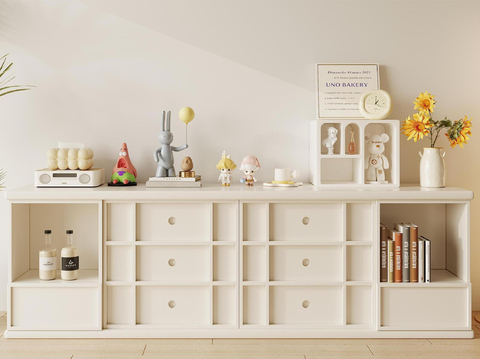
[380,223,432,283]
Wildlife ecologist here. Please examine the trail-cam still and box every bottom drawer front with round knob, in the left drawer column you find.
[137,286,211,325]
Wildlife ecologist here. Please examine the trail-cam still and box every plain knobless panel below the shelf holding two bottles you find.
[11,287,100,330]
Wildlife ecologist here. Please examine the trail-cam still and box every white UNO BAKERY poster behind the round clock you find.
[316,64,380,119]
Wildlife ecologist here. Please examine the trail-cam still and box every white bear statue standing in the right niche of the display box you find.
[365,133,390,184]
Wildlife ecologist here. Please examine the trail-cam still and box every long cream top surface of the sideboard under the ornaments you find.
[5,183,473,201]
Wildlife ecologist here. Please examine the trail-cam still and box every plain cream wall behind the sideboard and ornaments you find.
[0,0,480,310]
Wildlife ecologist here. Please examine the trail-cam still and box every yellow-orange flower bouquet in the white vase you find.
[402,91,473,148]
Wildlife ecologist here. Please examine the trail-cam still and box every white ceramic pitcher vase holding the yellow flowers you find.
[418,147,446,188]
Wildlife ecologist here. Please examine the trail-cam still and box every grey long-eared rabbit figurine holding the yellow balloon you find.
[153,111,188,177]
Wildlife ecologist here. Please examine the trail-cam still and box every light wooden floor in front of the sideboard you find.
[0,312,480,359]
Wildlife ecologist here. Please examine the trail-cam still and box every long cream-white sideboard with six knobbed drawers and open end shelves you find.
[5,184,473,338]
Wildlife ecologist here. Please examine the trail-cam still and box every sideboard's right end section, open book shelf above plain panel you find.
[377,201,471,330]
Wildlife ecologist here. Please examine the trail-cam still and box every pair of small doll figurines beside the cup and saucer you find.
[217,151,261,186]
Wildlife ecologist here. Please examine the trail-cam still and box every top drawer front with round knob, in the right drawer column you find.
[270,203,343,241]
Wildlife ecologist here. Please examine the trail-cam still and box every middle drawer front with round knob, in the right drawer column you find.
[270,246,343,282]
